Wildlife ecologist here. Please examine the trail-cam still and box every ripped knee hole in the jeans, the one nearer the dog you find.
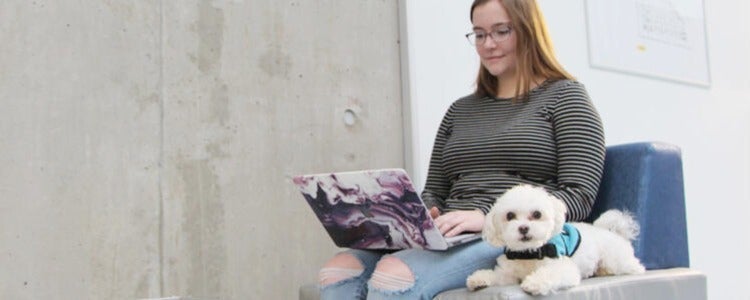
[370,256,414,291]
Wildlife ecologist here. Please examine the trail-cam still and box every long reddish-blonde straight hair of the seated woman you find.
[469,0,573,101]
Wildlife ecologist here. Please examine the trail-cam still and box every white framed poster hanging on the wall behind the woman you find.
[586,0,711,86]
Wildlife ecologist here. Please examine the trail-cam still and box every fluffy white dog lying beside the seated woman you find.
[466,185,645,295]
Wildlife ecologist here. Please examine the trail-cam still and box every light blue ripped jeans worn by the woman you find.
[321,241,503,300]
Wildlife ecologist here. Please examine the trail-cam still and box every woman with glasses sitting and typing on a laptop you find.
[320,0,604,299]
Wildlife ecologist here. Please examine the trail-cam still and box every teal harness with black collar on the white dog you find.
[505,223,581,259]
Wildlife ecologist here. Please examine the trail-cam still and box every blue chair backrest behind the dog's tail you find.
[587,142,690,269]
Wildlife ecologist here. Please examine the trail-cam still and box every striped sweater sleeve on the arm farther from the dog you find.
[422,105,453,211]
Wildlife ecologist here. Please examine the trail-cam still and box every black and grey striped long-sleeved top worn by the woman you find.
[422,80,604,221]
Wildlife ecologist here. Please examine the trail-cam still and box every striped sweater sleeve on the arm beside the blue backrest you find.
[550,82,605,221]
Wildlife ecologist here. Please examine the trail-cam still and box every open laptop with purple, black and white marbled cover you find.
[293,169,481,250]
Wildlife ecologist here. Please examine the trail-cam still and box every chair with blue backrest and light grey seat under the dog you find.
[300,142,707,300]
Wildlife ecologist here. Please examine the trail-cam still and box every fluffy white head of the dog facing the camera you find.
[482,185,567,251]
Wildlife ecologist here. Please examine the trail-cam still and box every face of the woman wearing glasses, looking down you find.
[472,1,517,78]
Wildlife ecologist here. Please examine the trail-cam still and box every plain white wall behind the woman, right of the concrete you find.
[404,0,750,299]
